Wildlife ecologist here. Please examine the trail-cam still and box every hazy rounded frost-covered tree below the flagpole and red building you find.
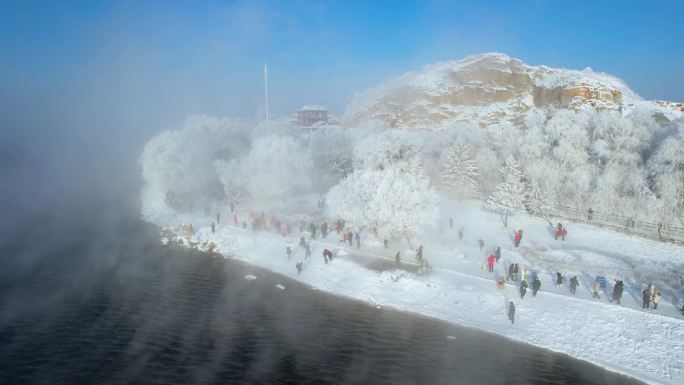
[216,135,313,200]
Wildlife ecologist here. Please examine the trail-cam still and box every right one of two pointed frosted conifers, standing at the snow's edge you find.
[487,156,525,226]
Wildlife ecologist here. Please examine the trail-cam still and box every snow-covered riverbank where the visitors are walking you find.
[147,198,684,384]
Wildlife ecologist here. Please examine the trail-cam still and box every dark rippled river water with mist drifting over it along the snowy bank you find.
[0,215,637,385]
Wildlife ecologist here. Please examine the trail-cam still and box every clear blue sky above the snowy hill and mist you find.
[0,1,684,120]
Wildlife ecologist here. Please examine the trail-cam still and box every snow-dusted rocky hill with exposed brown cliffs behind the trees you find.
[345,53,684,128]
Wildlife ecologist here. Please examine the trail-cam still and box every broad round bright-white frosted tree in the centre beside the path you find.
[327,168,437,241]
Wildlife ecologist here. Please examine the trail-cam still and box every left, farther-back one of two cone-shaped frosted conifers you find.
[443,140,480,197]
